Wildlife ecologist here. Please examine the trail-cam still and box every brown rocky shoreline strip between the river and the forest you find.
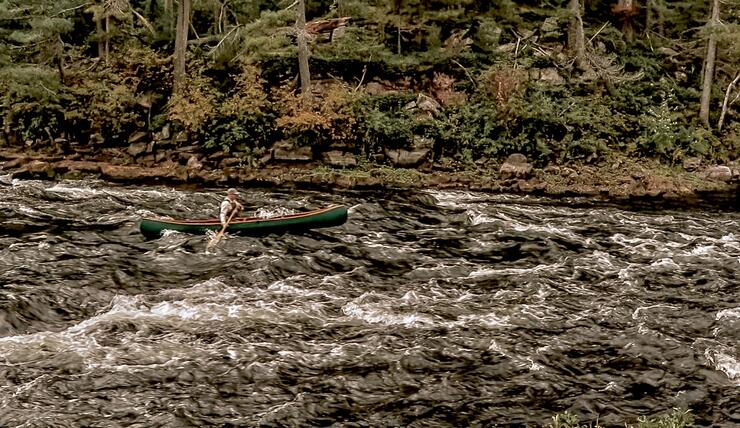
[0,148,740,210]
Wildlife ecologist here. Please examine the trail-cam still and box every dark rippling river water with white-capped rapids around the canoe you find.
[0,179,740,427]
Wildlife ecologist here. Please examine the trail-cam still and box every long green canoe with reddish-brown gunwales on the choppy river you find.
[139,205,347,239]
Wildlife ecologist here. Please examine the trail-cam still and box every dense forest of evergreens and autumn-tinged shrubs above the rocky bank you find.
[0,0,740,174]
